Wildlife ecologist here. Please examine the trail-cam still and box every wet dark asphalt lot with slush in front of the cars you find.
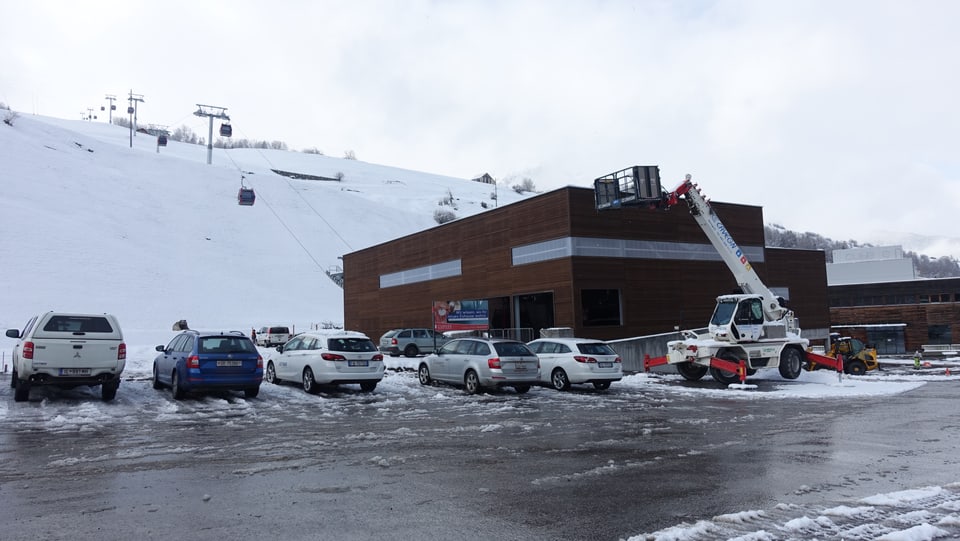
[0,362,960,540]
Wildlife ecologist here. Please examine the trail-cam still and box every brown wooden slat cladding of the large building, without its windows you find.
[344,187,827,339]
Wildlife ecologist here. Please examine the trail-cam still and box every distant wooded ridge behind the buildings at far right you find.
[763,224,960,278]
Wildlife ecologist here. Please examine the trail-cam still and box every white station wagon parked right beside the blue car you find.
[266,330,383,394]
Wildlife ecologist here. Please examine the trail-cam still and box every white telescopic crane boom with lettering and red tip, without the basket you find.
[665,175,787,321]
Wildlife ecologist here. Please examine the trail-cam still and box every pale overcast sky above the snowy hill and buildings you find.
[0,0,960,257]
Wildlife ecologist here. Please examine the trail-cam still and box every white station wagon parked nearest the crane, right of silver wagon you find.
[528,338,623,391]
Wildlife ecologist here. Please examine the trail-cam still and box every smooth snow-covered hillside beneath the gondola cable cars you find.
[0,116,523,347]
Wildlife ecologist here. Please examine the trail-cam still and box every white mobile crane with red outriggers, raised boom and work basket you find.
[594,165,842,384]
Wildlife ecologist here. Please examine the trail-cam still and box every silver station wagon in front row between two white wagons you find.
[417,338,540,394]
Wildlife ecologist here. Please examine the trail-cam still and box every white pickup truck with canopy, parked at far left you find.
[6,312,127,402]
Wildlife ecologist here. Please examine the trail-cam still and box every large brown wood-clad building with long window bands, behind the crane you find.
[343,187,829,340]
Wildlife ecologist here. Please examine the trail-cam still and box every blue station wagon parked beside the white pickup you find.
[153,330,263,400]
